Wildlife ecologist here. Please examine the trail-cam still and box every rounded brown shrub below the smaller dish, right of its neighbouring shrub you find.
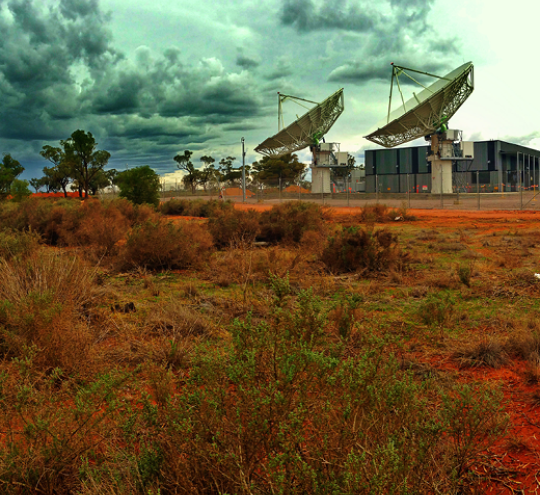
[260,201,325,244]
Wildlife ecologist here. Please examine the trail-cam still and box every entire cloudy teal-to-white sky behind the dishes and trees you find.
[0,0,540,182]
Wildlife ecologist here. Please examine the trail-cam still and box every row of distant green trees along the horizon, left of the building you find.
[0,129,355,204]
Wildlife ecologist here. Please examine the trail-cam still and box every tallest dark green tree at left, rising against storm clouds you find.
[60,129,111,198]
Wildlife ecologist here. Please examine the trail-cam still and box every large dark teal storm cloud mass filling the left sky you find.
[0,0,263,174]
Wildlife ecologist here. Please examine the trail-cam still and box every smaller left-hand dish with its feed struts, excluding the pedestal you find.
[255,88,344,158]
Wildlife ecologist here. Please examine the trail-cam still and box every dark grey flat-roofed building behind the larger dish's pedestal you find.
[365,141,540,193]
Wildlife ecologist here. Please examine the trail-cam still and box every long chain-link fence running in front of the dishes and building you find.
[150,171,540,210]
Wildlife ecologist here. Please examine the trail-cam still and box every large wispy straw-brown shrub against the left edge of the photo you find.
[0,252,95,372]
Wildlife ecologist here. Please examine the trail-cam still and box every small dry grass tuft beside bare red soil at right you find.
[453,336,508,368]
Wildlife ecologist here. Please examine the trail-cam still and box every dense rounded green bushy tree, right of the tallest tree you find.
[115,165,161,206]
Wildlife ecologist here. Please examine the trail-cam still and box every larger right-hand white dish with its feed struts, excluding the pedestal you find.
[365,62,474,148]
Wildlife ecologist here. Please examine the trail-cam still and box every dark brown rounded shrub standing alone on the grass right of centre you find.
[321,227,408,273]
